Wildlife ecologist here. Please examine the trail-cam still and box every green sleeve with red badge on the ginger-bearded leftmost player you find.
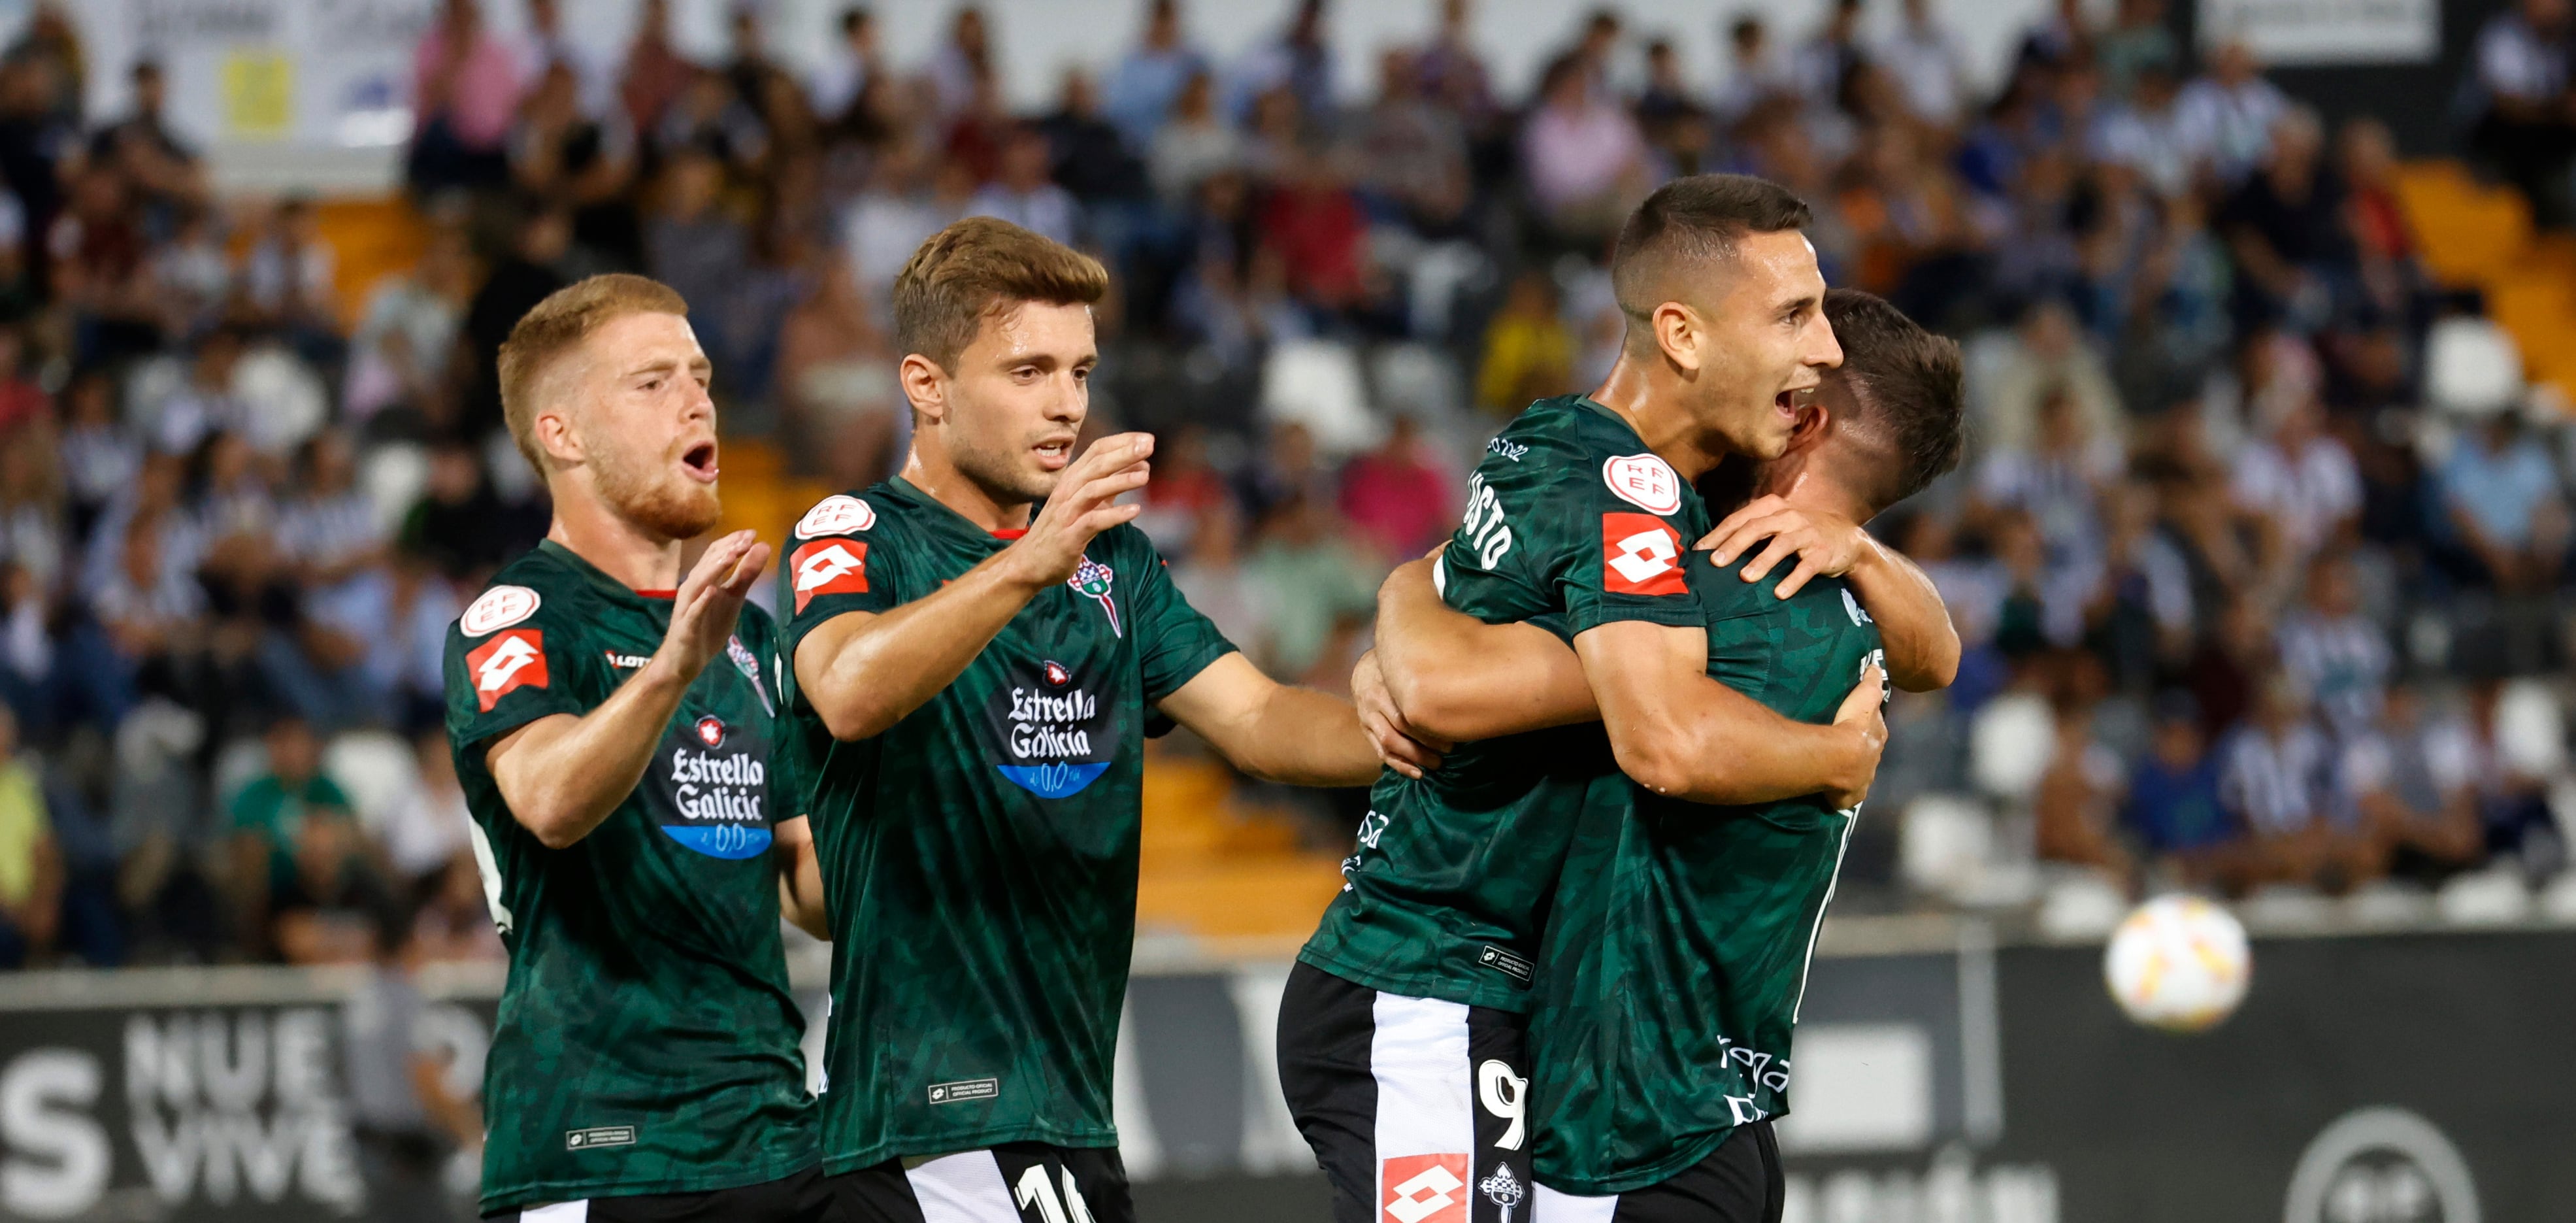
[446,587,605,744]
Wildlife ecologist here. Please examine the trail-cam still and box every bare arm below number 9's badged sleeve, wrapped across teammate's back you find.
[1574,620,1888,806]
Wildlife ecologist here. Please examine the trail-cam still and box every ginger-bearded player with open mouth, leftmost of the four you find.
[446,275,827,1223]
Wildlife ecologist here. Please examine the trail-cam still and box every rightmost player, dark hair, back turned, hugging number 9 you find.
[1378,288,1960,1223]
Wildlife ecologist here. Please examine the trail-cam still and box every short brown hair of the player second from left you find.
[894,216,1110,373]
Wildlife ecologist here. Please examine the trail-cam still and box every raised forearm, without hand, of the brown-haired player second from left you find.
[796,551,1038,741]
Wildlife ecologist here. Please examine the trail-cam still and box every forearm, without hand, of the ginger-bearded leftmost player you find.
[487,654,695,850]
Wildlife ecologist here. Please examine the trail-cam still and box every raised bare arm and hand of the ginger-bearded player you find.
[484,530,770,850]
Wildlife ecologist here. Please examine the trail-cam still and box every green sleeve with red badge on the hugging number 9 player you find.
[1532,453,1703,633]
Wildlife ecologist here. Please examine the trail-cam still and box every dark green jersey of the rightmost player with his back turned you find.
[1530,554,1886,1195]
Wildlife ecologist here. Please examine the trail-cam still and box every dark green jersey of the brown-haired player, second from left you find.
[780,479,1234,1174]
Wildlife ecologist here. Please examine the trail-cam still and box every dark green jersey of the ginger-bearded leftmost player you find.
[446,541,819,1213]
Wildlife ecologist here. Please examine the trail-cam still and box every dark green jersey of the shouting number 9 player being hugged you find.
[1298,397,1708,1012]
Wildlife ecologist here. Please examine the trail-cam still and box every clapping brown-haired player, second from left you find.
[780,216,1378,1223]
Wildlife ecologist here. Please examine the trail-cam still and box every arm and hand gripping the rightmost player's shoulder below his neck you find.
[1700,497,1960,693]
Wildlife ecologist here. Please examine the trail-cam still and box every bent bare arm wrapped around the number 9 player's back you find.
[1378,559,1600,741]
